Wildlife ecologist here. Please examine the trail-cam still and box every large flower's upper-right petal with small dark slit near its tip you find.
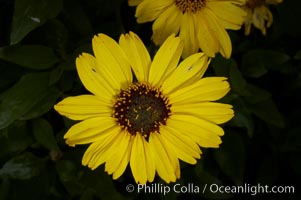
[162,53,209,94]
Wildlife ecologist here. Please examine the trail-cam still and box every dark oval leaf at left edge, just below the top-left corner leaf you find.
[0,45,59,70]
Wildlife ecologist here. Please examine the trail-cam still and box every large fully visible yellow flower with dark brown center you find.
[55,32,233,184]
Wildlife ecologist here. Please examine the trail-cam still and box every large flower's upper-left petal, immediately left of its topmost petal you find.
[92,34,132,91]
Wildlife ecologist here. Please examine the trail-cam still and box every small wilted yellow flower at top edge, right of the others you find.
[244,0,282,35]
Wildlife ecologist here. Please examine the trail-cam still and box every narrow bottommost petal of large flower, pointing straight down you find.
[130,133,147,184]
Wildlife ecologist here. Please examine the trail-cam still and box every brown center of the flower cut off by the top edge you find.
[175,0,206,14]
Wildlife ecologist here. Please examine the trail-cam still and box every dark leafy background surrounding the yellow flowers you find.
[0,0,301,200]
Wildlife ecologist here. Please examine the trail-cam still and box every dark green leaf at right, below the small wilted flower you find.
[241,49,290,78]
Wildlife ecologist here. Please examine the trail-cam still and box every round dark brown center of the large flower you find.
[113,83,171,139]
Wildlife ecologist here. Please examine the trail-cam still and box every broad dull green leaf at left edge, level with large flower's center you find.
[0,73,49,129]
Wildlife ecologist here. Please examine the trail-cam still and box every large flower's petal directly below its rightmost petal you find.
[167,114,224,148]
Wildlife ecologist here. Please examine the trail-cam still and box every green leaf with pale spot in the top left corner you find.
[10,0,63,44]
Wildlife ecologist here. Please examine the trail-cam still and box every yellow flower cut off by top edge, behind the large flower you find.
[129,0,246,58]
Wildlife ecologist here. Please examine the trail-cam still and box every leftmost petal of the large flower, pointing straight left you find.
[54,95,112,120]
